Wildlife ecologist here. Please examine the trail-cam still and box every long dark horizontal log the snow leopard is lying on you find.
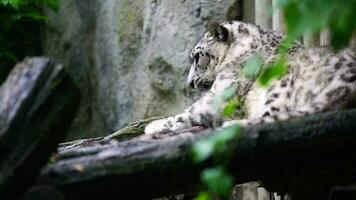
[38,110,356,199]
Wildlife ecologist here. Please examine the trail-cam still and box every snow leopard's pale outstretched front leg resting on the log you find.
[145,91,222,134]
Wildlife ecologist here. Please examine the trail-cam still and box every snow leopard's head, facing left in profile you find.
[187,21,261,90]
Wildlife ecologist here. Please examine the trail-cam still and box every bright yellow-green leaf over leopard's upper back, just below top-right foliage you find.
[258,58,287,86]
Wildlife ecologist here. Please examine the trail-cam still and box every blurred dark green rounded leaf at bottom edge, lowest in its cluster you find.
[201,167,234,198]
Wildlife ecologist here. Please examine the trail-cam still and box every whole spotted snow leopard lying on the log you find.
[145,21,356,134]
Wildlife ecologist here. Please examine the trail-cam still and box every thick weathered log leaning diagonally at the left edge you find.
[0,58,79,199]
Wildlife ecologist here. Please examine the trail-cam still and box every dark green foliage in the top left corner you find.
[0,0,58,84]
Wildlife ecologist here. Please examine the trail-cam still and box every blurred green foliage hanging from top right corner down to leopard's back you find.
[256,0,356,86]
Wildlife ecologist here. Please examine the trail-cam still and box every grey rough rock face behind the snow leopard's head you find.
[43,0,241,139]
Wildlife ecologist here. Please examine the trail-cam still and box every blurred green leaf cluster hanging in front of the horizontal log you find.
[192,125,240,200]
